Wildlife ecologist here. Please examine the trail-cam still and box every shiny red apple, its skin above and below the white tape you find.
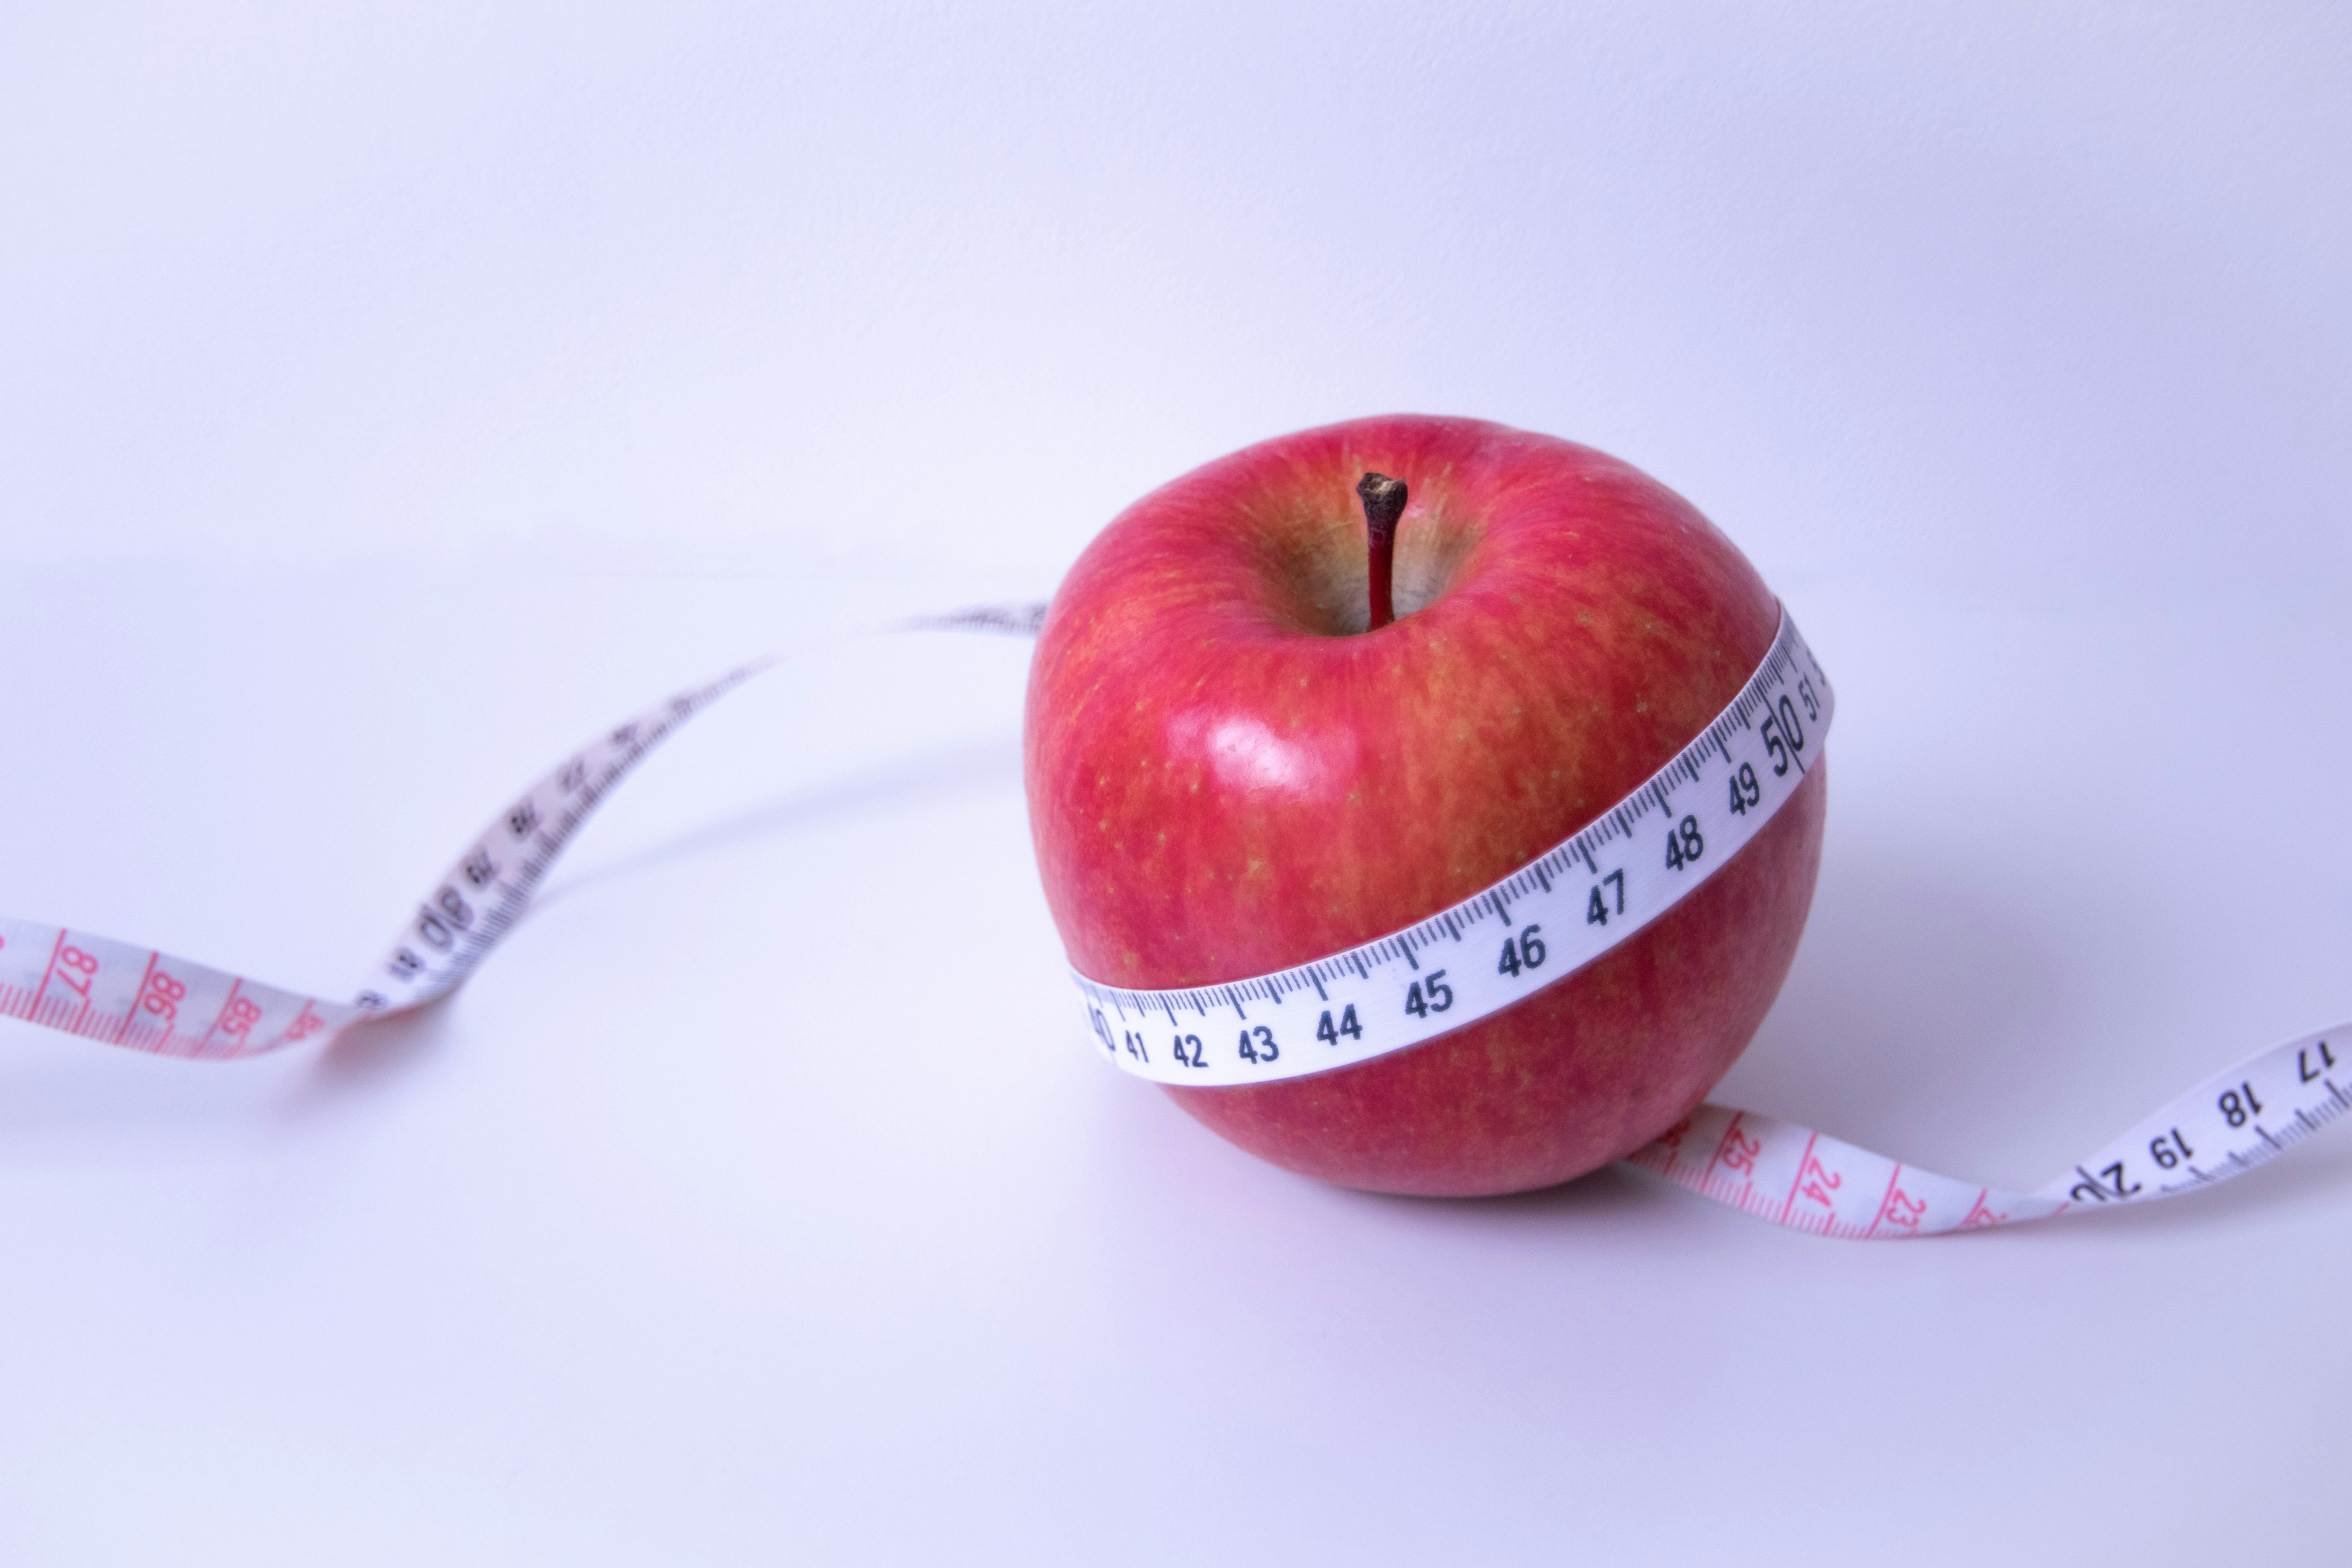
[1023,416,1825,1194]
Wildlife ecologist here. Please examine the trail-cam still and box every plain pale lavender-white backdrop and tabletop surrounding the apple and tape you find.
[0,5,2352,1563]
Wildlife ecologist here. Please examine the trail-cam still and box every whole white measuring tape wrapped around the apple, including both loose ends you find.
[0,604,2352,1239]
